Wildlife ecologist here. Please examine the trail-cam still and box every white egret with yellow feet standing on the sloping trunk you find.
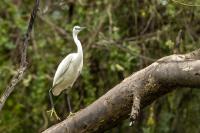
[49,26,85,119]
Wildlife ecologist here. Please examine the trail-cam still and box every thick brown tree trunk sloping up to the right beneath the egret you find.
[44,50,200,133]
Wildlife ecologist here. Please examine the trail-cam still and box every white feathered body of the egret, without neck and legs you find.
[52,53,83,96]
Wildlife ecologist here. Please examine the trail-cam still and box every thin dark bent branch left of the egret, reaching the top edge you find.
[0,0,39,111]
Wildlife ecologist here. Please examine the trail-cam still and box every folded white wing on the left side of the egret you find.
[53,53,74,86]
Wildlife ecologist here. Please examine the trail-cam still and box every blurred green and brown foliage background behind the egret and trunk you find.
[0,0,200,133]
